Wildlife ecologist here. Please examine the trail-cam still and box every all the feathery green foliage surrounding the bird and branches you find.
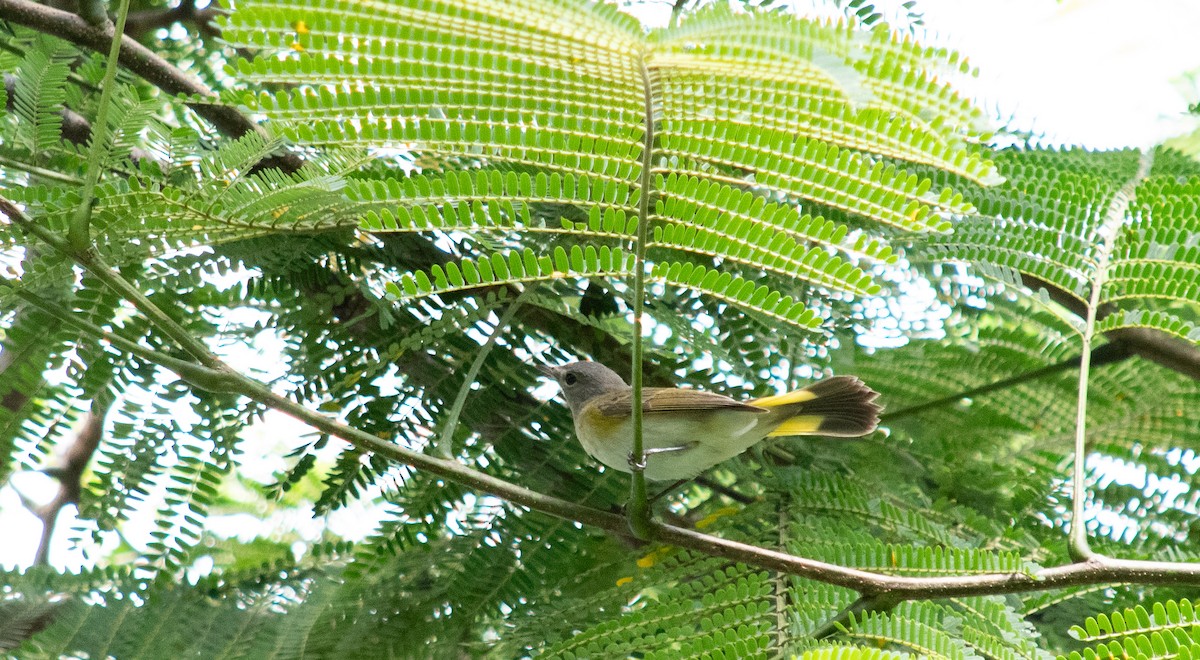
[0,0,1200,659]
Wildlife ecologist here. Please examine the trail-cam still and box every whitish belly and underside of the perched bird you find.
[575,410,769,481]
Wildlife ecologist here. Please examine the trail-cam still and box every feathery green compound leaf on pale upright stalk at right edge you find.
[929,149,1200,342]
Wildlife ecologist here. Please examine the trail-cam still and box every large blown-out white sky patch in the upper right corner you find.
[626,0,1200,149]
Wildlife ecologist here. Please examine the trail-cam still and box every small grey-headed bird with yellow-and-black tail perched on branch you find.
[539,361,882,481]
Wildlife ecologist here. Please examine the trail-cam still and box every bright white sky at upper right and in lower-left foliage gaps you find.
[0,0,1200,569]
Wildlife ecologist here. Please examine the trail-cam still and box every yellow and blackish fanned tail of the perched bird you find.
[748,376,883,438]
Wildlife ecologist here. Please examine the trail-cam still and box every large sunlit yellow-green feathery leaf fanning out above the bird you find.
[224,1,996,329]
